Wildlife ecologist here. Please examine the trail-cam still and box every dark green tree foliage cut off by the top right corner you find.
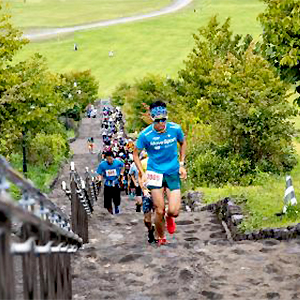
[259,0,300,97]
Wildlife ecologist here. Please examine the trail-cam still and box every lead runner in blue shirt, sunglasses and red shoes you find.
[133,100,187,244]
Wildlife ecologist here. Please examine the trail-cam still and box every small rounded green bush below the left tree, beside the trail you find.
[28,133,68,167]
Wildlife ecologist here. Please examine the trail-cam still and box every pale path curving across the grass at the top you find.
[24,0,193,40]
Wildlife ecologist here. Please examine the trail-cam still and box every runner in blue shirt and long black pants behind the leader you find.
[97,151,125,214]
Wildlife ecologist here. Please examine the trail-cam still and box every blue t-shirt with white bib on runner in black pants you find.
[97,159,124,186]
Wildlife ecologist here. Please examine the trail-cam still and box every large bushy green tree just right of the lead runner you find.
[179,18,296,184]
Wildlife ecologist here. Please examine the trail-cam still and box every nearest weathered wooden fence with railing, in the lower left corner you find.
[0,156,83,299]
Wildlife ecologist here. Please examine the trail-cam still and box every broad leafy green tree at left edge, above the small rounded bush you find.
[0,54,66,154]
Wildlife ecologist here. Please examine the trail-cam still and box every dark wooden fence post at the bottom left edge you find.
[0,210,15,299]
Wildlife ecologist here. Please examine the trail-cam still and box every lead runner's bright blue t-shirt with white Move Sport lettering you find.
[136,122,184,175]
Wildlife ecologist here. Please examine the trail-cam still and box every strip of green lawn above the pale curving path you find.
[4,0,172,28]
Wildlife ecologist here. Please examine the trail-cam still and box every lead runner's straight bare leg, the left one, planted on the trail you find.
[151,188,165,238]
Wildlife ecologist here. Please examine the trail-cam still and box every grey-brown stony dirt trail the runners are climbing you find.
[51,108,300,300]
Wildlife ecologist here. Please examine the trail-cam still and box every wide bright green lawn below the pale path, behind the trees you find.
[17,0,264,97]
